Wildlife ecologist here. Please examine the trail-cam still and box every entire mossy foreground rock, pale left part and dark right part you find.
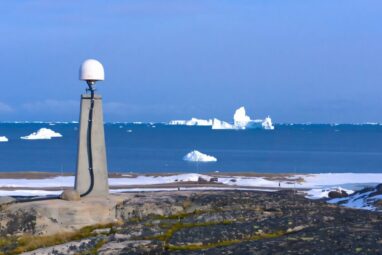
[0,190,382,254]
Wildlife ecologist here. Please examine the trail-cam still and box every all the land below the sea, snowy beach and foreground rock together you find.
[0,172,382,255]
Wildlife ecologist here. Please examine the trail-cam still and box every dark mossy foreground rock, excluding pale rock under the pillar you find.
[0,191,382,255]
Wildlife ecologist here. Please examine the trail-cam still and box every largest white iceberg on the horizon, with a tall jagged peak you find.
[168,106,275,130]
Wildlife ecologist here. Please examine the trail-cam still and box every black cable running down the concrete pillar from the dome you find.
[80,81,94,197]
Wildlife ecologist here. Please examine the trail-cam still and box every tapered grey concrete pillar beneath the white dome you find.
[75,94,109,196]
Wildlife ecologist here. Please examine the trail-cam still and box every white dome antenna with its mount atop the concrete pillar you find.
[80,59,105,90]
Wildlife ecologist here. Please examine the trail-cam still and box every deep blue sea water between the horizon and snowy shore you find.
[0,123,382,173]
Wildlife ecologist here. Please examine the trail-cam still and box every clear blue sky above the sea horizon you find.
[0,0,382,123]
